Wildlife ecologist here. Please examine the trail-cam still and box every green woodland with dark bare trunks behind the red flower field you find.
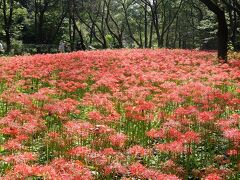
[0,0,240,60]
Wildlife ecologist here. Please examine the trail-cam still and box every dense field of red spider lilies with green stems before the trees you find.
[0,49,240,180]
